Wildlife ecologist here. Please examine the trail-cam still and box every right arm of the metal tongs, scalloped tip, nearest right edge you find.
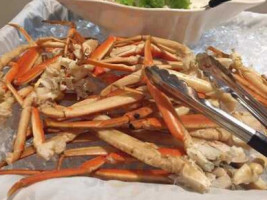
[197,53,267,127]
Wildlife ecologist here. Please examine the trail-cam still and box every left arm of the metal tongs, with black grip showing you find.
[145,66,267,156]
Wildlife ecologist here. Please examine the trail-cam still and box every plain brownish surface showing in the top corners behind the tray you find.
[0,0,267,27]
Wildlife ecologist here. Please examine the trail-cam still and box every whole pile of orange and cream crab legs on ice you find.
[0,21,267,196]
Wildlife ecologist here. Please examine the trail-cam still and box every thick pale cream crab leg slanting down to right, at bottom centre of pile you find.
[96,116,210,192]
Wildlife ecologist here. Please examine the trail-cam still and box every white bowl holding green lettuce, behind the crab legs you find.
[58,0,265,44]
